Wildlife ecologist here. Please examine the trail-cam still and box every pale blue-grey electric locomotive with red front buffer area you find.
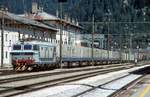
[11,41,56,71]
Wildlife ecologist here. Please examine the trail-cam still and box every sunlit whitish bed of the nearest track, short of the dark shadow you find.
[71,74,143,97]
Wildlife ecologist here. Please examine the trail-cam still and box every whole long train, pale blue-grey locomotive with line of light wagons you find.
[10,40,134,71]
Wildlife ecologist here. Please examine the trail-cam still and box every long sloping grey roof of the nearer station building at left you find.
[0,11,57,31]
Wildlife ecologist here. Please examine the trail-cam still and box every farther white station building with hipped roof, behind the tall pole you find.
[21,10,84,45]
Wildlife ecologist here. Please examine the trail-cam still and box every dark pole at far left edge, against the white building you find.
[1,9,4,68]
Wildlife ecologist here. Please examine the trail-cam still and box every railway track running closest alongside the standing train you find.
[0,64,130,81]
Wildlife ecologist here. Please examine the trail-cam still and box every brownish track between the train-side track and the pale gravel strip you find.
[0,65,133,97]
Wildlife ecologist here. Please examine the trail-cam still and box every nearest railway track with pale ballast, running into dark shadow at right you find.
[71,68,149,97]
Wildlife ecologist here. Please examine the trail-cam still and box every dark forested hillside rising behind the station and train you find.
[0,0,150,47]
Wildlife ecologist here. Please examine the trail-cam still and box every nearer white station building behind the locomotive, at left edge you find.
[0,11,57,67]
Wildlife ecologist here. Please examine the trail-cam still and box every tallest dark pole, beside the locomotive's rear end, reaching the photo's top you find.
[58,0,67,68]
